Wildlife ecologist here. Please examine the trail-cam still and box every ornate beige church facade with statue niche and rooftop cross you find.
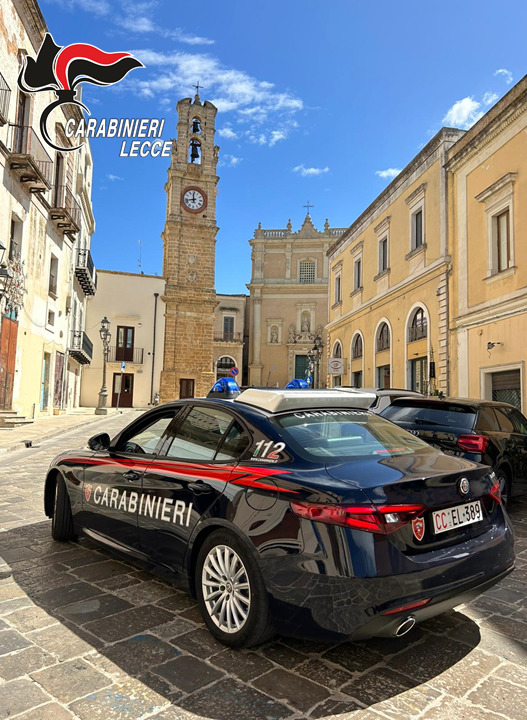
[247,214,344,387]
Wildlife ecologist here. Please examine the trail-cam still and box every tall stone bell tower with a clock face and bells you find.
[160,91,219,402]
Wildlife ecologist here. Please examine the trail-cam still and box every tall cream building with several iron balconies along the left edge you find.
[0,0,96,418]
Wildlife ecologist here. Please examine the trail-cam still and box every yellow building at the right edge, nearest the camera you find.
[447,76,527,411]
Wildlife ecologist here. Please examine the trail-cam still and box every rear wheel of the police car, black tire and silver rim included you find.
[195,530,274,647]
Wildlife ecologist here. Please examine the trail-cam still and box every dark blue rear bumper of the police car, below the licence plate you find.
[263,523,514,640]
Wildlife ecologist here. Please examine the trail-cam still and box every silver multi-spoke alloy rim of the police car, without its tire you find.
[201,545,251,633]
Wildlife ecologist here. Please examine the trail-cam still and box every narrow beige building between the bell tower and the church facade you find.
[214,295,248,385]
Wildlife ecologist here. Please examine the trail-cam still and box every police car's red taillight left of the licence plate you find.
[289,501,426,535]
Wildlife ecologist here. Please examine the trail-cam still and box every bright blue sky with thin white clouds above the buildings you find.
[40,0,527,293]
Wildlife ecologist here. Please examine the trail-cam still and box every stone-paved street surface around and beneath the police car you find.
[0,415,527,720]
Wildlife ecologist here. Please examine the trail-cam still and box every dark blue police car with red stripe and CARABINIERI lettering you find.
[45,389,514,646]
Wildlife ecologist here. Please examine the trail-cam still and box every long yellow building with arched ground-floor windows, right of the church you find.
[327,128,463,393]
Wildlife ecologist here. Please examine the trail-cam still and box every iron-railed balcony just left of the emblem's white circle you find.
[8,124,53,192]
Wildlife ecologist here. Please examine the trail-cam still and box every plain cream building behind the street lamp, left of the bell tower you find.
[81,270,165,408]
